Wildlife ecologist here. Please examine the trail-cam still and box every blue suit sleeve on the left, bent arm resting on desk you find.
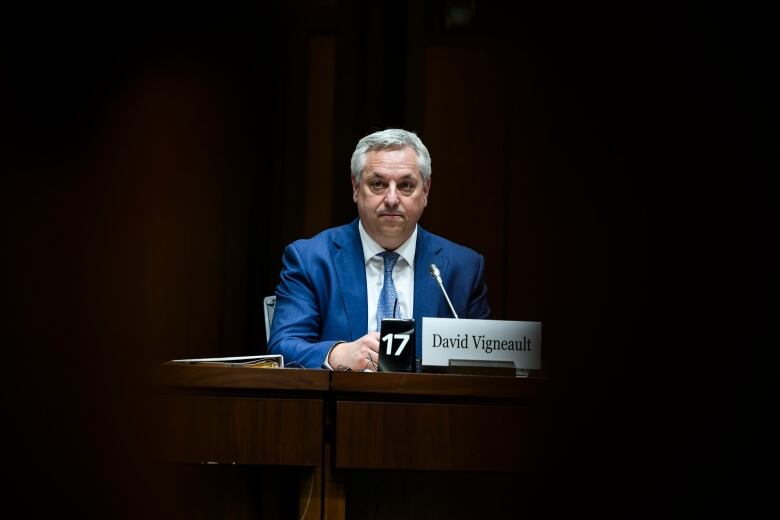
[268,243,335,368]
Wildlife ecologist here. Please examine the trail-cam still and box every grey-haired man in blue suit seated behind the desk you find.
[268,129,490,371]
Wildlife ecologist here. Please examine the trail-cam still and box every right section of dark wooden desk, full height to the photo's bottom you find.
[325,372,543,518]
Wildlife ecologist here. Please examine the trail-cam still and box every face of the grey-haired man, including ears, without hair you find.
[352,148,431,250]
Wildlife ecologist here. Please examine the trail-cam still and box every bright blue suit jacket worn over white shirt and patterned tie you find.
[268,219,490,368]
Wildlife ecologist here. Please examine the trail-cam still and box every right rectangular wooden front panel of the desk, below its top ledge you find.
[336,401,530,471]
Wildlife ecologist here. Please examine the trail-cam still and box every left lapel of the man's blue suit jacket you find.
[331,220,368,341]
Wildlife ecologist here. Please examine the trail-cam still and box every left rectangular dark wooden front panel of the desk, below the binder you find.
[158,396,324,466]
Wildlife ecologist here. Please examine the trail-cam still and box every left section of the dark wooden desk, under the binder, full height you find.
[156,364,330,518]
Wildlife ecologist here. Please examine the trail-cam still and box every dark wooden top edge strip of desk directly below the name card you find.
[331,372,544,399]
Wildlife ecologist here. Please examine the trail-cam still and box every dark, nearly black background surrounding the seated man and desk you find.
[2,0,778,517]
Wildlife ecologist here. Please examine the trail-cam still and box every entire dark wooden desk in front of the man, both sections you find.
[156,364,544,519]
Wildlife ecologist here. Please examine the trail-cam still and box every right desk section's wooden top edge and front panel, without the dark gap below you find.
[331,372,539,471]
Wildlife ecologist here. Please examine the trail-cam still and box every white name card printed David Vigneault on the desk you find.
[418,317,542,370]
